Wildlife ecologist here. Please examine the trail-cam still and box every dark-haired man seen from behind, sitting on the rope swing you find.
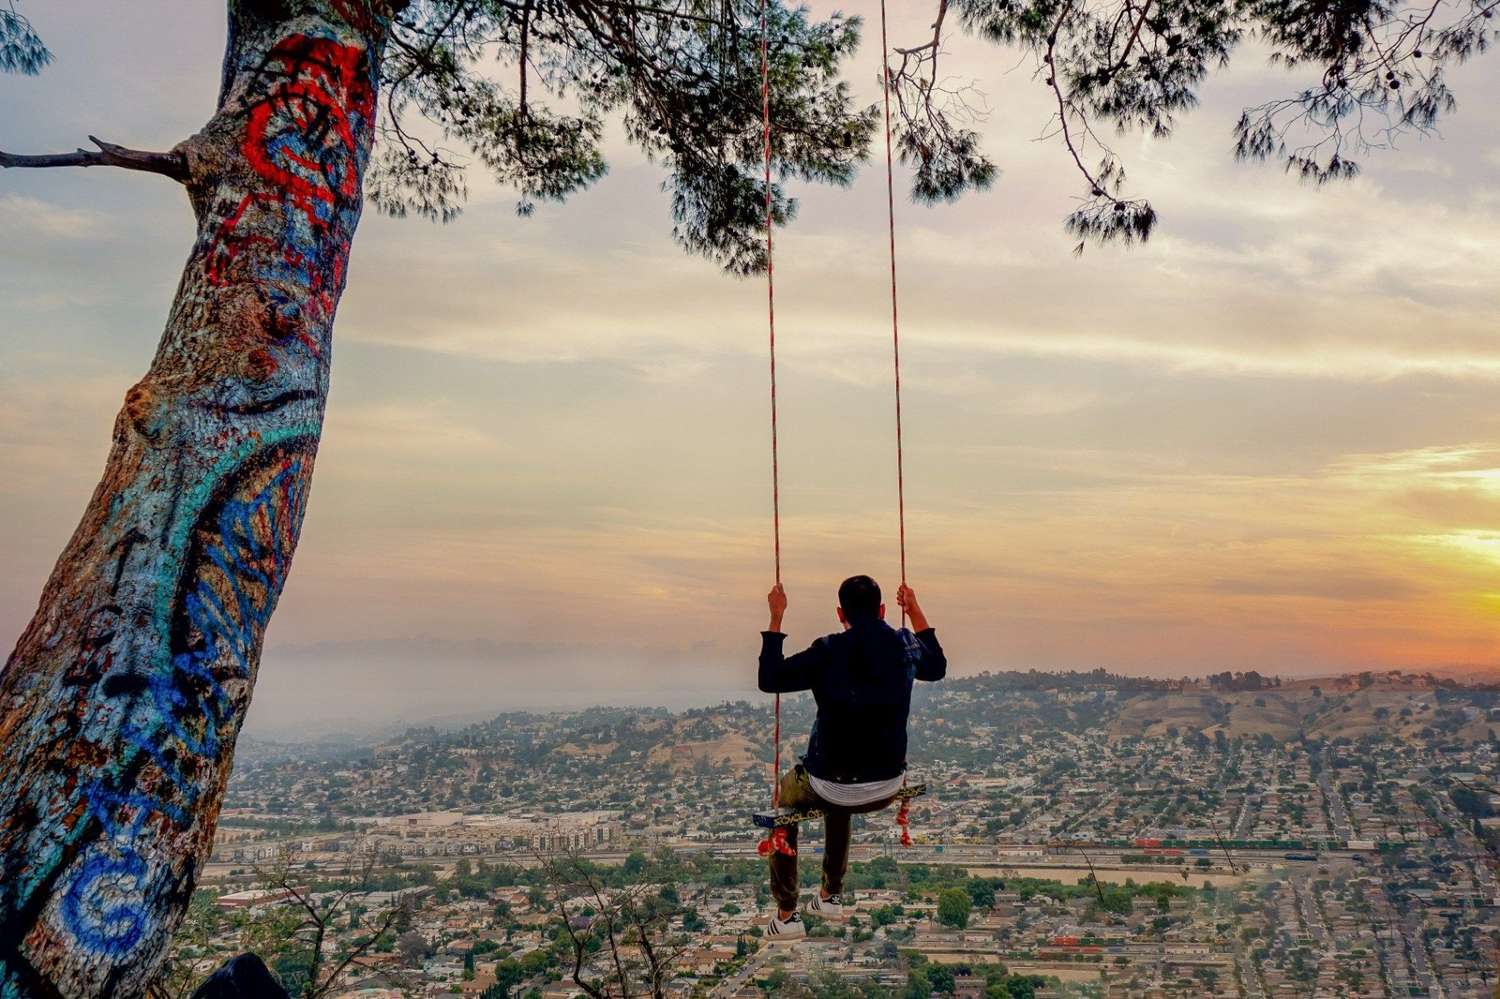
[761,576,948,941]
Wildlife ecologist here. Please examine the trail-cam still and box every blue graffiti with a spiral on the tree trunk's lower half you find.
[0,428,317,995]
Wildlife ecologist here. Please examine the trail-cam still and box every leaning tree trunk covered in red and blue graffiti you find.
[0,0,393,999]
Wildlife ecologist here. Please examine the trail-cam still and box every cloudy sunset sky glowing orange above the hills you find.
[0,0,1500,732]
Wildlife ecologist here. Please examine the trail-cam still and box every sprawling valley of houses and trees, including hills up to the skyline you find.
[174,674,1500,999]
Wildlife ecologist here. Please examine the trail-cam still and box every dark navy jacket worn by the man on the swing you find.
[761,620,948,785]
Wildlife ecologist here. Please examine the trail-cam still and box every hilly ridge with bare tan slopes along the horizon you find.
[242,671,1500,771]
